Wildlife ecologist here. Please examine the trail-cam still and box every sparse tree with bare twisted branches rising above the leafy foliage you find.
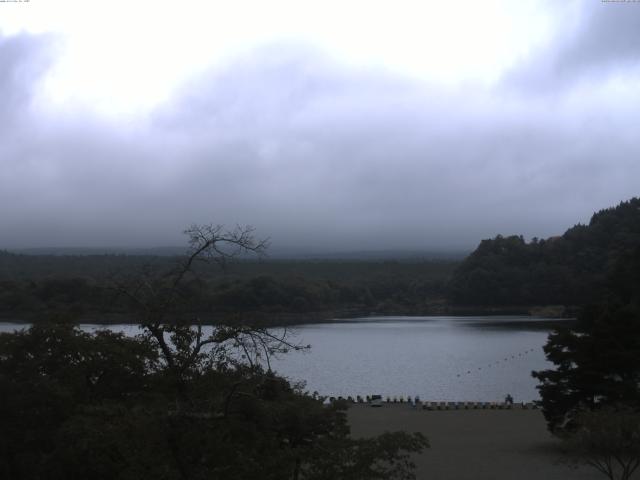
[112,225,306,397]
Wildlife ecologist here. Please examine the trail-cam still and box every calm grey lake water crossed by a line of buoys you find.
[0,316,551,401]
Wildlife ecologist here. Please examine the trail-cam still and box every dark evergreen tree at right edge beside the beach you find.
[533,246,640,431]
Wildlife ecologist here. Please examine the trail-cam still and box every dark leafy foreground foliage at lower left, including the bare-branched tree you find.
[0,226,428,480]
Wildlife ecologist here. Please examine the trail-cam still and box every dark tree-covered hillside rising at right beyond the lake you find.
[449,198,640,305]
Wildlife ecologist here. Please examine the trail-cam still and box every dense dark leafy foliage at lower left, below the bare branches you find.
[0,325,427,480]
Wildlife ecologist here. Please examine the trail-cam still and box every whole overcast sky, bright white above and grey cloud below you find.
[0,0,640,250]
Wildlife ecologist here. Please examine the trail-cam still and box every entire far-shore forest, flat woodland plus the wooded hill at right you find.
[0,198,640,323]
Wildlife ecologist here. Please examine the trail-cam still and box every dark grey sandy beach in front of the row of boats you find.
[348,404,640,480]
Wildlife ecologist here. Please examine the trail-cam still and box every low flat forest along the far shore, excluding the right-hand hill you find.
[0,252,459,323]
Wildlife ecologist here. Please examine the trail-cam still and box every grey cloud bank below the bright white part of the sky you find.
[0,9,640,250]
